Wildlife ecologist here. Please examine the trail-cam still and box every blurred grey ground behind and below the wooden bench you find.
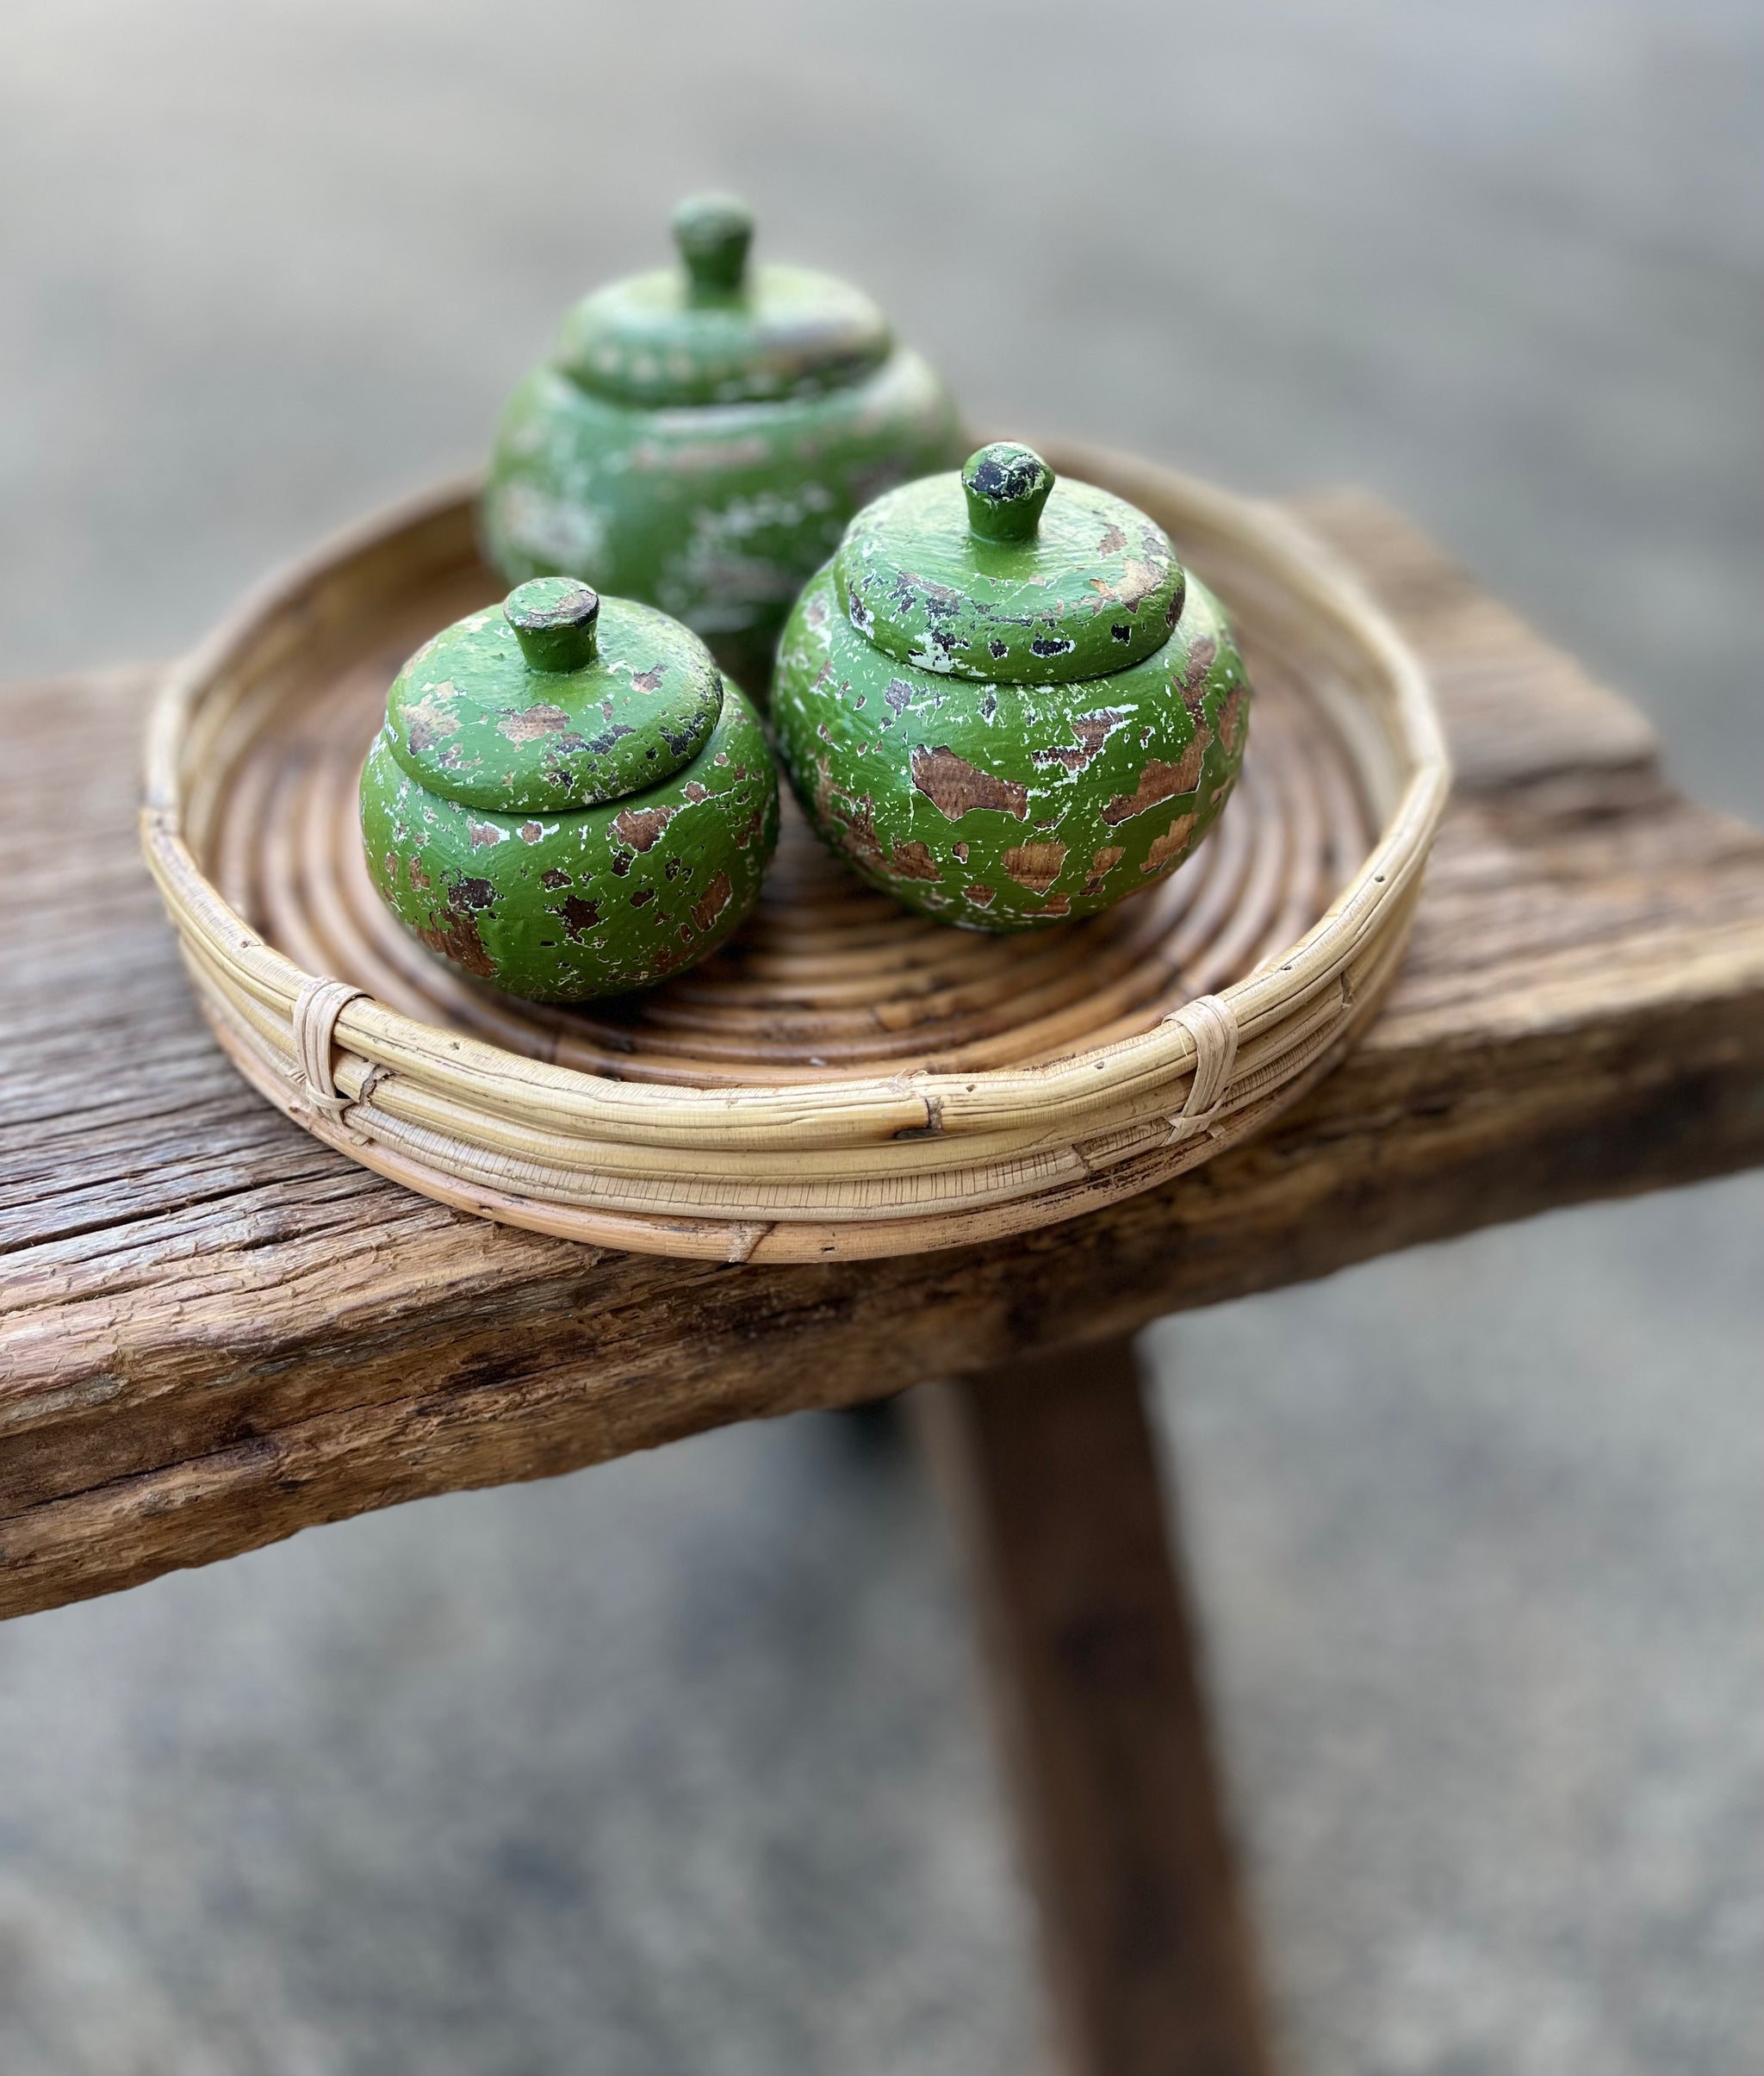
[0,0,1764,2076]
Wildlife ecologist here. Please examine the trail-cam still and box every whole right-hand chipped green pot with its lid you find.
[772,444,1249,930]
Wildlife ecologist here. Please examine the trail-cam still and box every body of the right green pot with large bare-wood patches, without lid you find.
[772,565,1249,930]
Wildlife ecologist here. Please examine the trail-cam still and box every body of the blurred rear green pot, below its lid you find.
[480,346,961,698]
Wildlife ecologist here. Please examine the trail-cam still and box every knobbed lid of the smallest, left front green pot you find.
[386,577,722,814]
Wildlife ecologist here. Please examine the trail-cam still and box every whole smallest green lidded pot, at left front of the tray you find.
[361,577,779,1003]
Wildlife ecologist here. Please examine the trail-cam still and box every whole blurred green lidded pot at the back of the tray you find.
[480,196,961,698]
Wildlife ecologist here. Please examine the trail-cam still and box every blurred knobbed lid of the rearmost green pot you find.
[554,196,892,409]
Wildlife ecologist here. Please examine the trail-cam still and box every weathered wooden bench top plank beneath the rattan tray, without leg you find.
[0,500,1764,1613]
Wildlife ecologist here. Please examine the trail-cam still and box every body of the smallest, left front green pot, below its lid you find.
[361,683,779,1003]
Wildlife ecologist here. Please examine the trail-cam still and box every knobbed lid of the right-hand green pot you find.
[835,442,1185,685]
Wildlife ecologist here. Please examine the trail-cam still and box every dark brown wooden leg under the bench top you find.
[926,1341,1270,2076]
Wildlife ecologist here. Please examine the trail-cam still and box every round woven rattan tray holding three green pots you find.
[143,446,1449,1260]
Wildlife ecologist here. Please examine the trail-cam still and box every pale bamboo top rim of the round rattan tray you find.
[141,454,1450,1153]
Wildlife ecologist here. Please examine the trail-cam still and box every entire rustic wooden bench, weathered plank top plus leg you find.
[0,496,1764,2076]
